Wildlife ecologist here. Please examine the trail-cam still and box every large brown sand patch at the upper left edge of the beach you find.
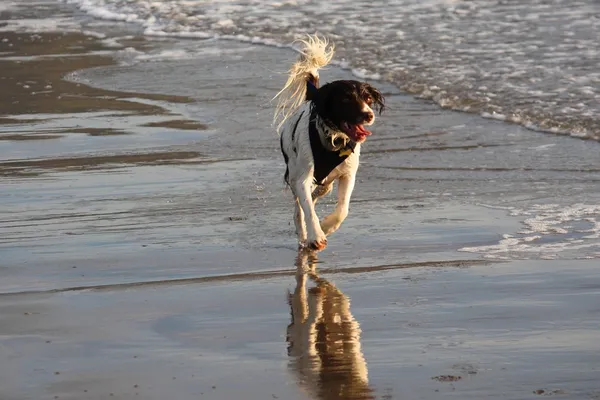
[0,32,192,116]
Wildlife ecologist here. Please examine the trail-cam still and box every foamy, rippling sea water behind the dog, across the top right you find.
[56,0,600,139]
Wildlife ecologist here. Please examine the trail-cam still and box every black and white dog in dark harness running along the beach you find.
[275,36,384,250]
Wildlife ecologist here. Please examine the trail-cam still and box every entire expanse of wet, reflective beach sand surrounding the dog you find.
[0,3,600,400]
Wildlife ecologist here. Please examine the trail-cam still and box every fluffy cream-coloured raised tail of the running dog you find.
[273,35,334,131]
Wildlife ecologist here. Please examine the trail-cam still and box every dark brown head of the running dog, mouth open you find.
[311,80,385,143]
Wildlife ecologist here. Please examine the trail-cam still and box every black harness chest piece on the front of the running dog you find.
[308,107,357,185]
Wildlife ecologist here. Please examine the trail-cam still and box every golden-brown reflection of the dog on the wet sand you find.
[287,251,374,400]
